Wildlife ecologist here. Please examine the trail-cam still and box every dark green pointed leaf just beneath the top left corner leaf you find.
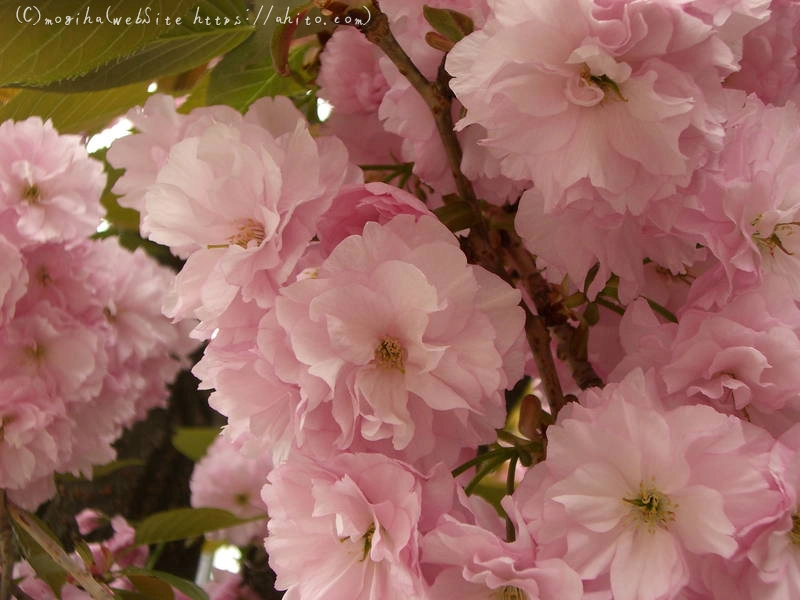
[39,0,254,92]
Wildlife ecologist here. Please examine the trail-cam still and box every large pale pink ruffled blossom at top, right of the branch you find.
[447,0,735,214]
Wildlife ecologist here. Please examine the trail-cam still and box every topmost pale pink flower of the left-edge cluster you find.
[0,117,106,245]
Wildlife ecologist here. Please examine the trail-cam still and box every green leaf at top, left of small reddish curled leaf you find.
[206,12,308,112]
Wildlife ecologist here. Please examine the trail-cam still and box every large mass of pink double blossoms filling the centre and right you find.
[109,0,800,600]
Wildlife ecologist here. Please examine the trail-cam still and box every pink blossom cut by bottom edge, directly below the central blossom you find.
[263,453,454,600]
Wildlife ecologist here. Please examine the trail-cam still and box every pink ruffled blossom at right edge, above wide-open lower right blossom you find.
[613,290,800,434]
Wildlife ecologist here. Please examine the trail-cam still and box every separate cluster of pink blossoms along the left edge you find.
[0,118,192,508]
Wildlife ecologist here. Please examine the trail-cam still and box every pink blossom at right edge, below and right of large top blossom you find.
[676,96,800,302]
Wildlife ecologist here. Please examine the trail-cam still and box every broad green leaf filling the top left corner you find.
[0,0,196,87]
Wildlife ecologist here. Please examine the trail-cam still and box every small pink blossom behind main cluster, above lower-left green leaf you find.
[189,437,272,546]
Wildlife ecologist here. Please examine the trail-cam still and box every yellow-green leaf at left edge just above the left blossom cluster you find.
[0,83,148,133]
